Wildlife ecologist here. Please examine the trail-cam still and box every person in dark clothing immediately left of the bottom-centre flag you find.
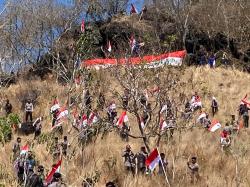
[135,147,148,174]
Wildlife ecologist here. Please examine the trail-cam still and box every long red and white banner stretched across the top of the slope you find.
[83,50,186,69]
